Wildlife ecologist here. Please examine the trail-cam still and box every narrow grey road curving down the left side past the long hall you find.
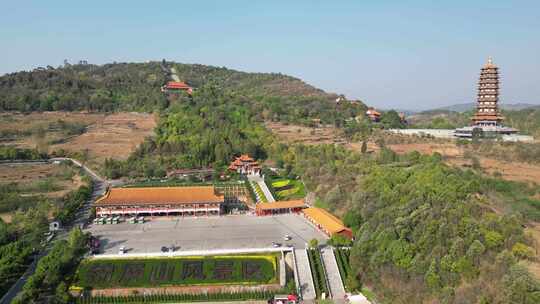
[0,157,107,304]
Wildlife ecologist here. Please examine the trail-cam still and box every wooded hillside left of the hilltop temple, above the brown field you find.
[0,63,166,111]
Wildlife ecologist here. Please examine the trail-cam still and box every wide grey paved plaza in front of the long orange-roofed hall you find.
[87,214,326,254]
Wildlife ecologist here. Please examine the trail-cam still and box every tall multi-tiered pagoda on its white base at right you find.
[454,57,517,138]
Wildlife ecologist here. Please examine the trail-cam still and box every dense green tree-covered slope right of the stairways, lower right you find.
[272,145,540,304]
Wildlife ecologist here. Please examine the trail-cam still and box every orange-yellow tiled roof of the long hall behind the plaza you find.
[95,186,223,206]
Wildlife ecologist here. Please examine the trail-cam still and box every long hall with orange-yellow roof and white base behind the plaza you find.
[94,186,224,216]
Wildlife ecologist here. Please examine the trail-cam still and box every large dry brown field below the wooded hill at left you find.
[0,112,156,166]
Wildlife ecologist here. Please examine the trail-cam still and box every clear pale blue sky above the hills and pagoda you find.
[0,0,540,109]
